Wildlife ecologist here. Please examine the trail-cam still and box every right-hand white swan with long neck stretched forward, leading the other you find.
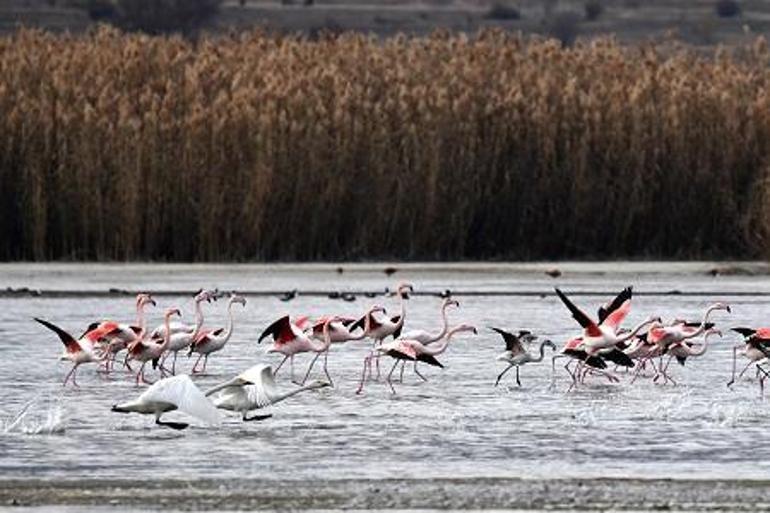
[206,364,330,422]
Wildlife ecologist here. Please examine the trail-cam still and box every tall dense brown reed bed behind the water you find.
[0,29,770,261]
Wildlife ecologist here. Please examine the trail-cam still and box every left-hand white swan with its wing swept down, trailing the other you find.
[112,374,220,430]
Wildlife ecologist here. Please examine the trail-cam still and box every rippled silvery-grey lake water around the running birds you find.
[0,264,770,480]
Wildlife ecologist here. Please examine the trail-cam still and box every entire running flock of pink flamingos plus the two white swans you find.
[35,283,770,429]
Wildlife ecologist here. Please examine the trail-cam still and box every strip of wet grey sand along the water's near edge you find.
[0,477,770,511]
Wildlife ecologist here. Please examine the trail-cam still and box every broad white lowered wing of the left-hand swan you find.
[139,374,220,424]
